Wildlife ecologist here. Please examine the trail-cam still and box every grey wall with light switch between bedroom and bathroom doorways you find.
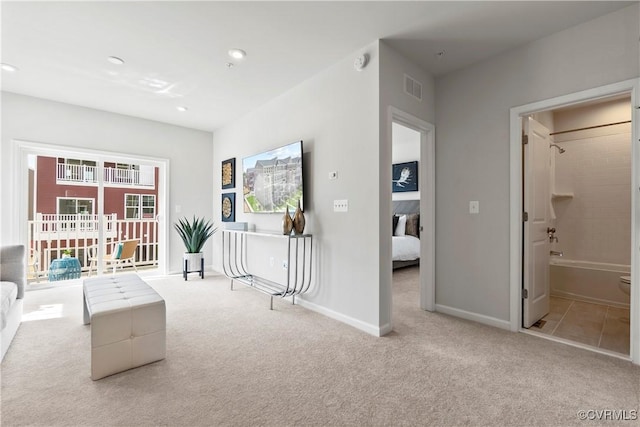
[435,4,640,327]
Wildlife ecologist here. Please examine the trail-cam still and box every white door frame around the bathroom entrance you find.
[509,79,640,365]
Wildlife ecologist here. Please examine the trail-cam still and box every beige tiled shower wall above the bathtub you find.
[553,126,631,265]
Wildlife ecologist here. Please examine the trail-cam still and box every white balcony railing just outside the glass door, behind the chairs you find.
[28,213,158,282]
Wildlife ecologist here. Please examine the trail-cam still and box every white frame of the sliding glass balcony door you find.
[12,139,170,275]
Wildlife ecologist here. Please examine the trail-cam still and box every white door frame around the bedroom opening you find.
[387,106,436,314]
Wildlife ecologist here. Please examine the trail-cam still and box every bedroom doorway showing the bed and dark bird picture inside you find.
[389,108,435,324]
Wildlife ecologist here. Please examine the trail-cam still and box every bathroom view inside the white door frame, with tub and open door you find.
[523,93,632,356]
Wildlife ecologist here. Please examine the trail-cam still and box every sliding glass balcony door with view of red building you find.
[16,141,167,289]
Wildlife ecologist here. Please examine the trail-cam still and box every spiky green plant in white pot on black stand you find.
[173,215,218,280]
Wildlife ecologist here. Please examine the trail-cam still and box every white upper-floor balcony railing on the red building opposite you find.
[56,163,155,188]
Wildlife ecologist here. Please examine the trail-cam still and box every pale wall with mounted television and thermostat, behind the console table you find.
[213,42,382,334]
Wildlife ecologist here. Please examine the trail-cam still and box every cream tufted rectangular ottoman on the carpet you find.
[83,274,166,381]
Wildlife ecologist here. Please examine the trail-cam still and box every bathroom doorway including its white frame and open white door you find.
[511,81,640,363]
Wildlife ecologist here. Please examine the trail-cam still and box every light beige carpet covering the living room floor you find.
[1,269,640,426]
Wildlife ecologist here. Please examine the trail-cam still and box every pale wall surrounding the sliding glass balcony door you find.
[0,92,213,272]
